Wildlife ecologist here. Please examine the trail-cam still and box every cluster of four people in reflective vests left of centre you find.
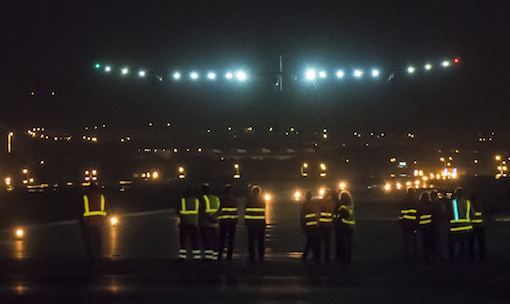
[177,184,266,261]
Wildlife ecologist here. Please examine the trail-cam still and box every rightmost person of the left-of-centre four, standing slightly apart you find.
[244,186,266,262]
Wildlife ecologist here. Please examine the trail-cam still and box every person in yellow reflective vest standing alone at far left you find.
[80,183,106,266]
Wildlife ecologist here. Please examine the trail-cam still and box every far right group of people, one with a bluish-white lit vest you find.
[399,187,486,261]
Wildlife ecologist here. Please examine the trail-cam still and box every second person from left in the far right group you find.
[418,192,434,261]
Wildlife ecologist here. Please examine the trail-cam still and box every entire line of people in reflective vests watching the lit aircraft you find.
[80,184,486,264]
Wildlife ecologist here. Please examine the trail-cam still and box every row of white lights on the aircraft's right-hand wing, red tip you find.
[304,58,460,81]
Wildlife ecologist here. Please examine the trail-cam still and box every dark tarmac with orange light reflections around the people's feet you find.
[0,191,510,303]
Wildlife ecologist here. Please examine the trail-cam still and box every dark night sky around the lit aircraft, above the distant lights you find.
[0,0,510,140]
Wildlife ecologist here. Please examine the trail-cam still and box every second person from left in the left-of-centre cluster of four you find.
[198,183,220,261]
